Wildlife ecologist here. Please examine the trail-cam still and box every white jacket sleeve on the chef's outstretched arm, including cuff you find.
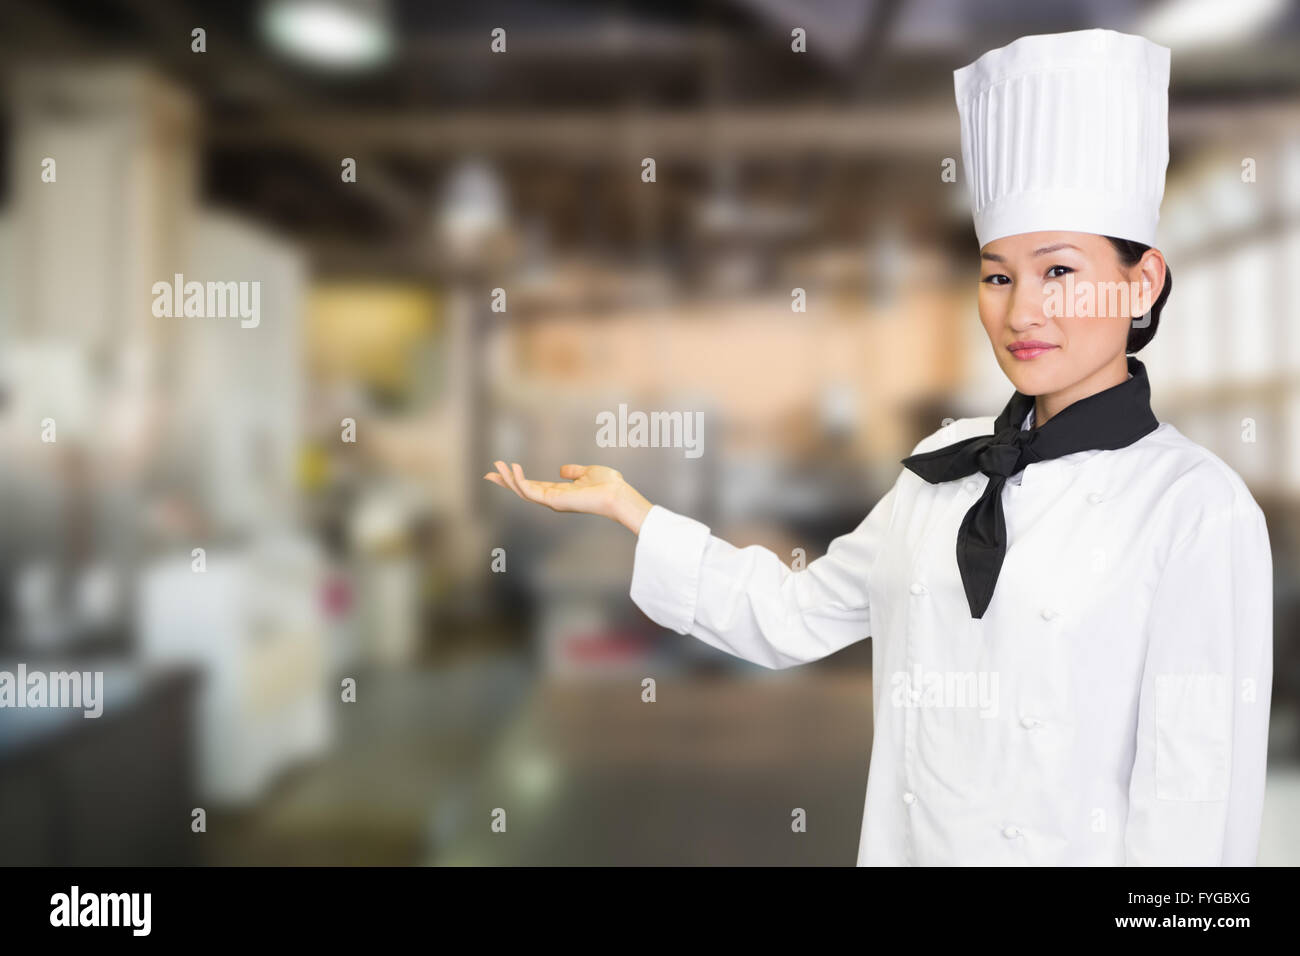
[631,485,897,669]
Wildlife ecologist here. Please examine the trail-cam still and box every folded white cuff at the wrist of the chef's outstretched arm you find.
[631,505,710,635]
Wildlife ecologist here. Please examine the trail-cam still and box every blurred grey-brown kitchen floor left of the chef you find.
[208,661,871,865]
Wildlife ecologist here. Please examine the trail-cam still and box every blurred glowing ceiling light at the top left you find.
[261,0,393,68]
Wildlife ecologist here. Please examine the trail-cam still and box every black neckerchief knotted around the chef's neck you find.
[902,355,1160,618]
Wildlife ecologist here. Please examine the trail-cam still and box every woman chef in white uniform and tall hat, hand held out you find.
[485,30,1273,865]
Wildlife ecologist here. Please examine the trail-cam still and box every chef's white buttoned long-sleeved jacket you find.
[631,411,1273,866]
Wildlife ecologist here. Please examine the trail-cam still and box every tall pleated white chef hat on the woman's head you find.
[953,30,1169,247]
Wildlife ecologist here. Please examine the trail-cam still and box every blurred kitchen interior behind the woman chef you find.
[0,0,1300,865]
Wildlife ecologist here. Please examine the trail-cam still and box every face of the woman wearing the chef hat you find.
[979,232,1165,397]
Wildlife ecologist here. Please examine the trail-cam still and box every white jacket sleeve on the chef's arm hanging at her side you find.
[1125,499,1273,866]
